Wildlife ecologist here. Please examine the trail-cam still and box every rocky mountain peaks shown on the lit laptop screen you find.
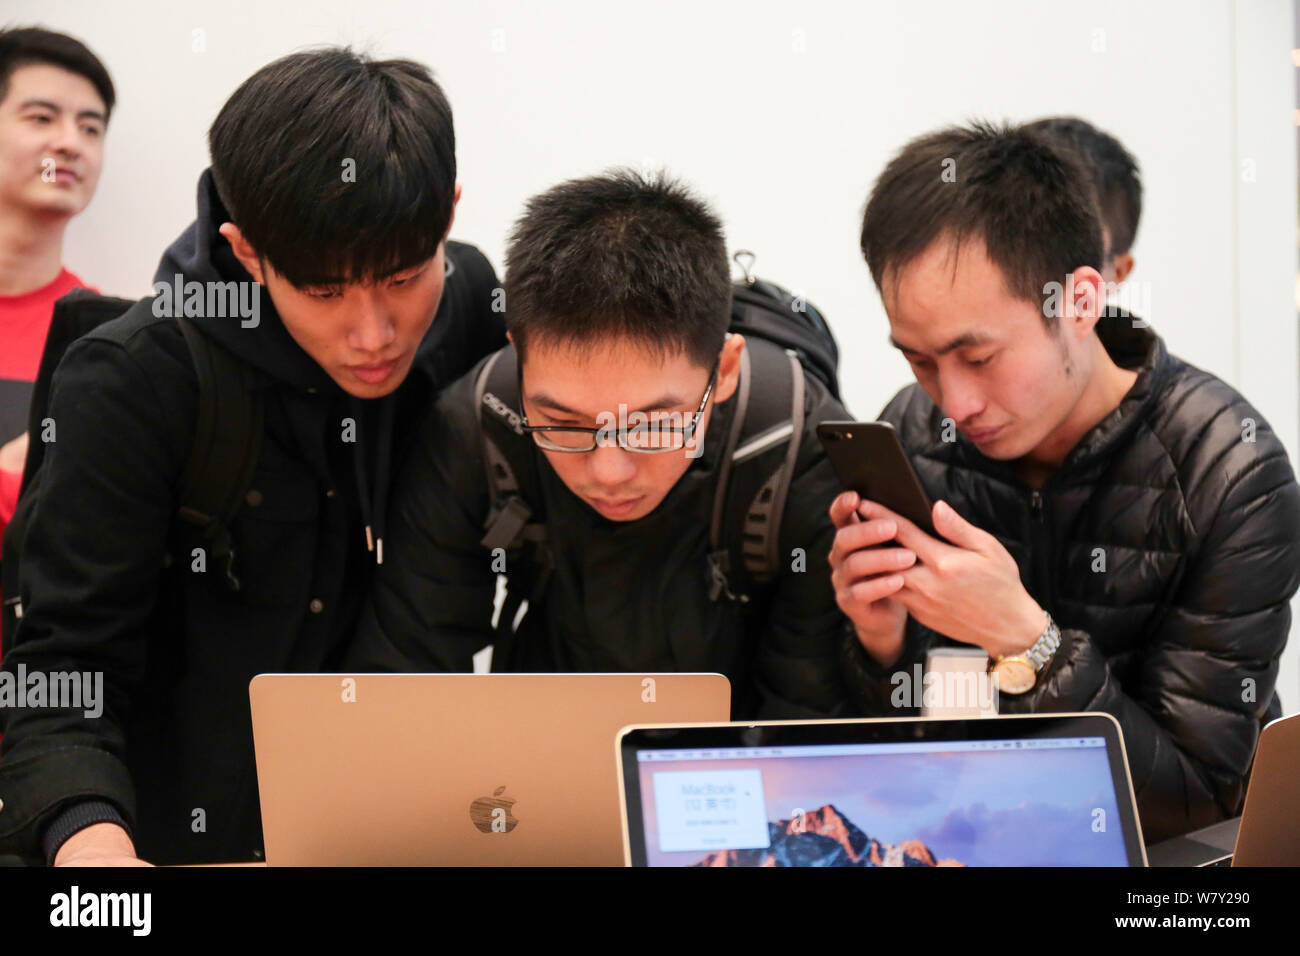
[694,804,965,866]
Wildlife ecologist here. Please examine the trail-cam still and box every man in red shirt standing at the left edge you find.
[0,27,114,554]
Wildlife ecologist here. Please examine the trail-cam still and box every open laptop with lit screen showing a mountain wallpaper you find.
[618,713,1147,866]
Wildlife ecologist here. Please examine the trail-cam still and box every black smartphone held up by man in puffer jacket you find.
[816,421,939,537]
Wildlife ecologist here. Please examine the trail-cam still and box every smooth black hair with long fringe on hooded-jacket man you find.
[208,47,456,287]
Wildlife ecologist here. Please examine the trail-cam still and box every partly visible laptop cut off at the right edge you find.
[1148,714,1300,866]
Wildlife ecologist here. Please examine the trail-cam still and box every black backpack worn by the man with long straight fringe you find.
[0,289,263,650]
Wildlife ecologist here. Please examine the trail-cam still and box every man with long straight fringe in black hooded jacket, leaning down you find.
[0,48,504,864]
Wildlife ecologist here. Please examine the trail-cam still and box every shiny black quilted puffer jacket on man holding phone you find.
[848,316,1300,843]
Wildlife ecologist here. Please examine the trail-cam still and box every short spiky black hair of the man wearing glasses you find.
[506,168,731,368]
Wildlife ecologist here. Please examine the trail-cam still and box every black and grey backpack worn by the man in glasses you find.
[475,252,840,671]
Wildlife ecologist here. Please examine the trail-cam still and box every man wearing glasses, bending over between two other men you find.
[345,170,852,719]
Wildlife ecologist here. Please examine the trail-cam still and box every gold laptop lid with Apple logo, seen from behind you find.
[250,674,731,866]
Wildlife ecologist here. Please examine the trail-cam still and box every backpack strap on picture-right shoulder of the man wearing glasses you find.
[710,338,805,604]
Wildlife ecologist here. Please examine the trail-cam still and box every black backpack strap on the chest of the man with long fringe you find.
[177,317,264,591]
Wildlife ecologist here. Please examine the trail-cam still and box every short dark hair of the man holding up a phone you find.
[862,122,1104,321]
